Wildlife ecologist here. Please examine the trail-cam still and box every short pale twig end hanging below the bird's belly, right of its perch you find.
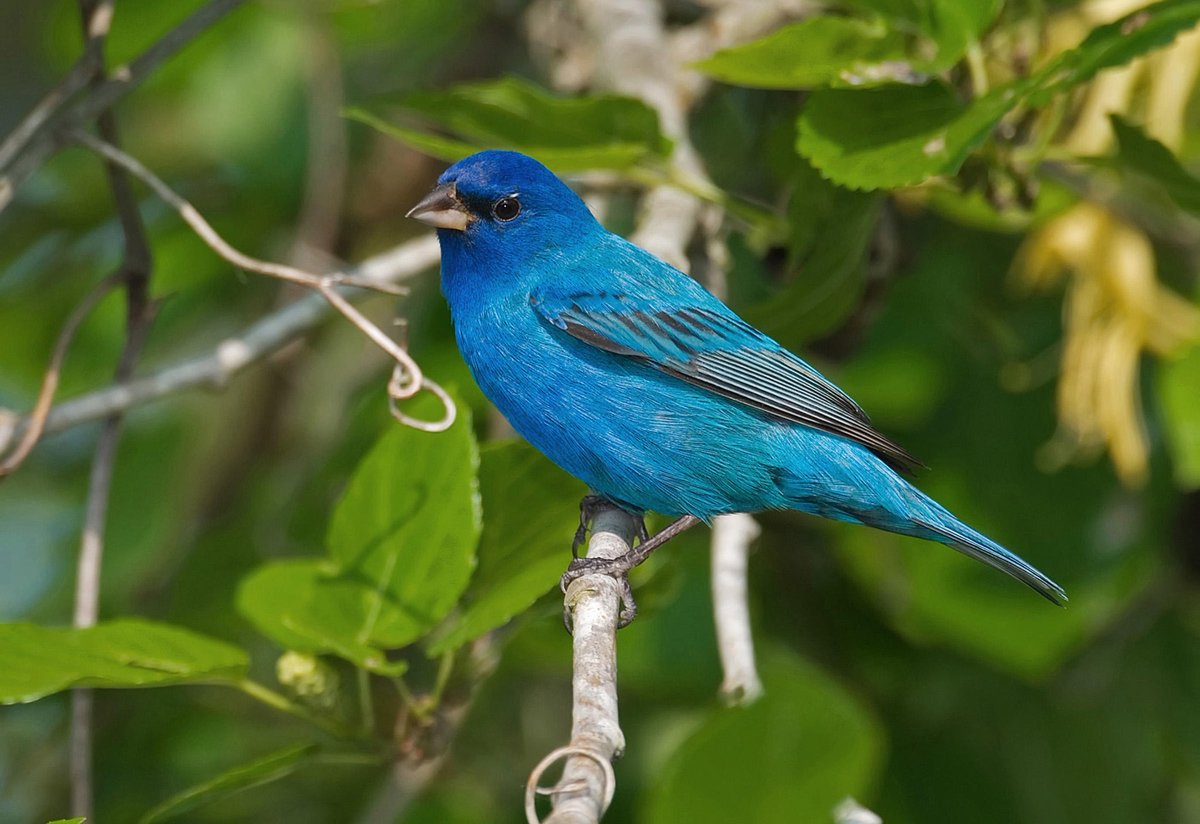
[712,512,762,704]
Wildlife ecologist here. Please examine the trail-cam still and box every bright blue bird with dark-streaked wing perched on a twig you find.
[409,151,1067,605]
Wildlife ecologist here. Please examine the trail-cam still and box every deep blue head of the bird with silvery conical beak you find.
[408,150,599,263]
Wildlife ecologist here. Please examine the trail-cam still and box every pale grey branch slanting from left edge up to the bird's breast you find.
[0,235,438,452]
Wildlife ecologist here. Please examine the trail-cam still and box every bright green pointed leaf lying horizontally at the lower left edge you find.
[0,618,248,704]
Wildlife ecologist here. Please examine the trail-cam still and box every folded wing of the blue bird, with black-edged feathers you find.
[529,290,920,469]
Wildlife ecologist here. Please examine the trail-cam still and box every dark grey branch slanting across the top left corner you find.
[0,0,245,211]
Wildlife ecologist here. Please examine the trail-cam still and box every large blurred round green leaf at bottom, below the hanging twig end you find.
[646,651,883,824]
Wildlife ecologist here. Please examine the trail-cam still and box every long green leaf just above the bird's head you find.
[347,78,671,172]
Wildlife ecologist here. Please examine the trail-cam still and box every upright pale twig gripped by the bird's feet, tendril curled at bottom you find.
[526,506,638,824]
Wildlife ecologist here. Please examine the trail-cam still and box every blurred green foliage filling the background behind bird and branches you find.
[0,0,1200,824]
